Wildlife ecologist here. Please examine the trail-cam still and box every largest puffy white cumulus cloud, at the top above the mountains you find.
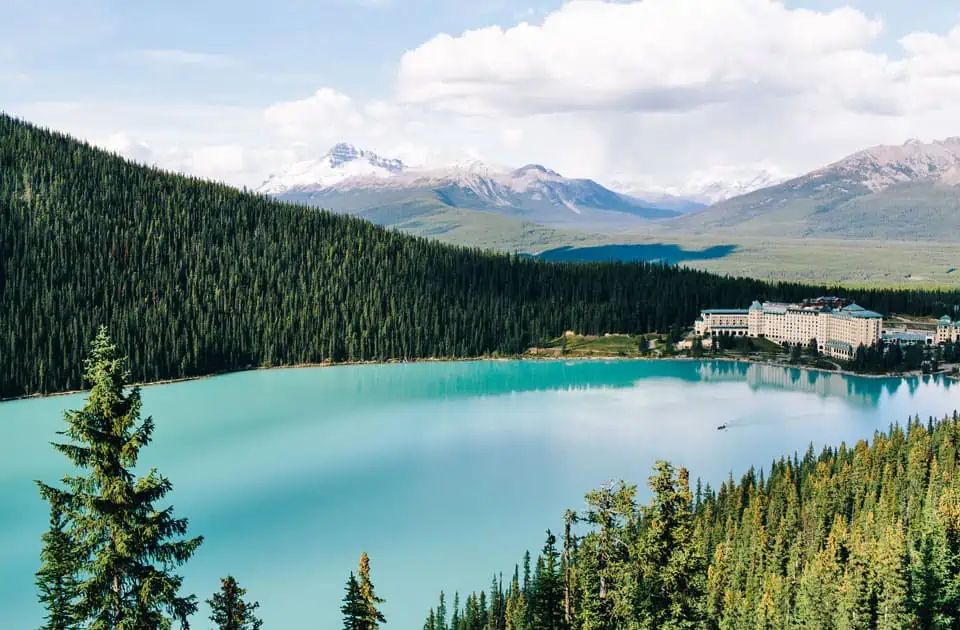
[398,0,883,114]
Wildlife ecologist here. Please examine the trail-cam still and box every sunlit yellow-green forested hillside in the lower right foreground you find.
[432,413,960,630]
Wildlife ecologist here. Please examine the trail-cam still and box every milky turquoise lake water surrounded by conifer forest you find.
[0,361,960,629]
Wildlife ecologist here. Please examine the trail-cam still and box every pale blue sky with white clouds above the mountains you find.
[0,0,960,192]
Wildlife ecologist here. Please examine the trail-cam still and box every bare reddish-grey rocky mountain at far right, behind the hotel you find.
[688,138,960,241]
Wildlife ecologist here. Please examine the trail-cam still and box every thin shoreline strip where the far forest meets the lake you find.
[0,354,948,403]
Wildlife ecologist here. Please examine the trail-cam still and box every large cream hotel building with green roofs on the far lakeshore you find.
[694,298,883,360]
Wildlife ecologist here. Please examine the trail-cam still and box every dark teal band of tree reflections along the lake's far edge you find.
[212,360,946,407]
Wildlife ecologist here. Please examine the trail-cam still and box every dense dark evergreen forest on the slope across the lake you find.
[0,115,960,397]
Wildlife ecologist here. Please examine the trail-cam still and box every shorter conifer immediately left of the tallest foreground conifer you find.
[37,502,79,630]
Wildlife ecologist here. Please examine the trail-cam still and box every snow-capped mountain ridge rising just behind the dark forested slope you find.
[258,144,680,227]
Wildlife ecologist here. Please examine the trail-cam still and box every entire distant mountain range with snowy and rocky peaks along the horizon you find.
[258,138,960,250]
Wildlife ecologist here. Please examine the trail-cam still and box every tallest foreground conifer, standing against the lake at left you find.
[38,328,202,630]
